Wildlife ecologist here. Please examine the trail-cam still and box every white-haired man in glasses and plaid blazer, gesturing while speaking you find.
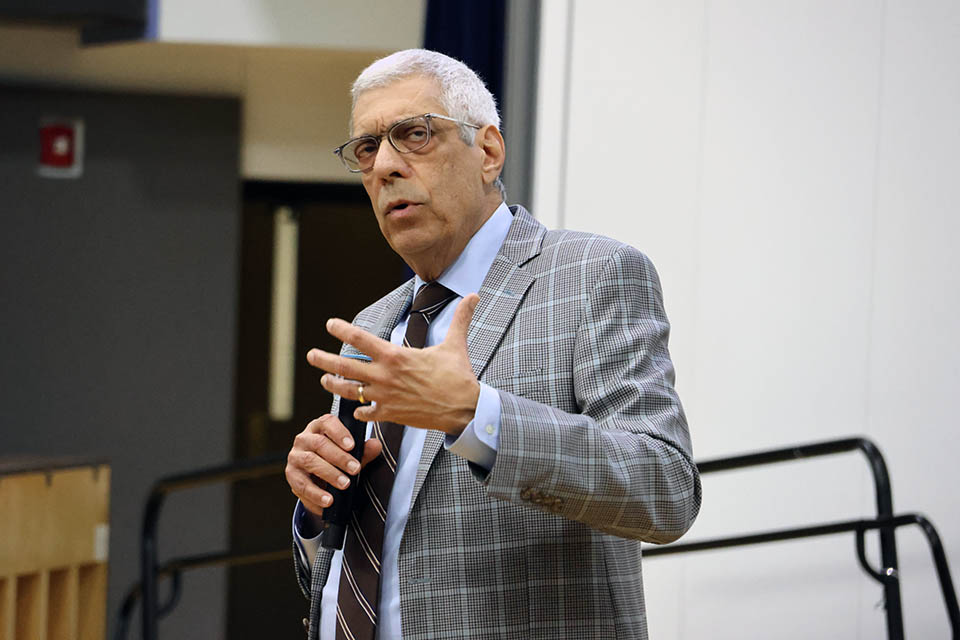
[286,50,700,640]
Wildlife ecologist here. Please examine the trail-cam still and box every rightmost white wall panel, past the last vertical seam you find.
[862,0,960,638]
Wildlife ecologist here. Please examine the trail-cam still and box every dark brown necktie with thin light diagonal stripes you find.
[337,282,457,640]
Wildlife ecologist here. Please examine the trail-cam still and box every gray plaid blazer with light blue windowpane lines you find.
[294,207,700,640]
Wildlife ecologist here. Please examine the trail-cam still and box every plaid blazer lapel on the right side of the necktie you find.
[406,205,547,509]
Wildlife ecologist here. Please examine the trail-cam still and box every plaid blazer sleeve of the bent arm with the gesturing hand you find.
[481,245,701,543]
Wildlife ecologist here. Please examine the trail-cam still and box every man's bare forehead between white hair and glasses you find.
[352,76,446,135]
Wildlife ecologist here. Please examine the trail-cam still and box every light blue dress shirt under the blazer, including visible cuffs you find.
[293,203,513,640]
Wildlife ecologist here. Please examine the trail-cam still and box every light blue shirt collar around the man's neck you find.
[413,202,513,298]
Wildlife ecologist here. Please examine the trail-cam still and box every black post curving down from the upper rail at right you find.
[858,438,904,640]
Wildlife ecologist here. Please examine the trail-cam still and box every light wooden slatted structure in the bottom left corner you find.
[0,457,110,640]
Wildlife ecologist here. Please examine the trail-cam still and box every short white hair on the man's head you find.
[350,49,506,199]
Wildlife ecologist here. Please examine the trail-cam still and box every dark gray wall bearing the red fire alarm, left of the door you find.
[0,87,240,638]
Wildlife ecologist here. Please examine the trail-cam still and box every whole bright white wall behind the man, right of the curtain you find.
[534,0,960,640]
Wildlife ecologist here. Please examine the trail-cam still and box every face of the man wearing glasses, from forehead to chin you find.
[352,76,499,280]
